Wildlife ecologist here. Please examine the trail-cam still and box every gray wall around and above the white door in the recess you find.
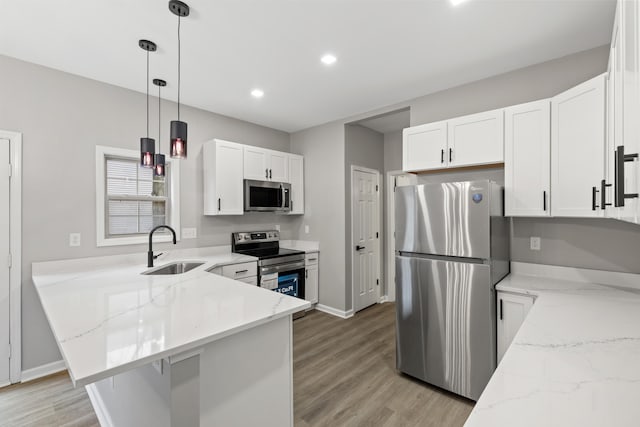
[344,125,384,307]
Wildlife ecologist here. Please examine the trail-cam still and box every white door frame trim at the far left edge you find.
[0,130,22,383]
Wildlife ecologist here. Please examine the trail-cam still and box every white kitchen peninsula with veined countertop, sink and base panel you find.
[33,247,310,427]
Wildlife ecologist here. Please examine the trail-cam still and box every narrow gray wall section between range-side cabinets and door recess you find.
[291,122,345,310]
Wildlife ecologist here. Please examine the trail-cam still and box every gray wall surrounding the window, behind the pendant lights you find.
[0,56,298,370]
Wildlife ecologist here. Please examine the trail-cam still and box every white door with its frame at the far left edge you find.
[0,131,22,387]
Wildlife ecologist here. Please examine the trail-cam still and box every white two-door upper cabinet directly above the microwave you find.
[244,145,289,182]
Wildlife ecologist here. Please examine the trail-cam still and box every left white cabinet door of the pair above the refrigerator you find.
[402,122,447,171]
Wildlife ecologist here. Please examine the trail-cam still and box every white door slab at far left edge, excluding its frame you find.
[0,139,10,386]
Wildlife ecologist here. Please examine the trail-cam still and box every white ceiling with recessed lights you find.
[0,0,615,132]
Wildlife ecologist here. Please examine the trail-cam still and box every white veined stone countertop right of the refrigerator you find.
[465,264,640,427]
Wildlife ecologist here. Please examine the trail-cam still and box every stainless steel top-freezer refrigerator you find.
[395,180,510,400]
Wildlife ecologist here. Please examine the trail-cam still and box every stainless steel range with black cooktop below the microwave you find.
[231,230,305,299]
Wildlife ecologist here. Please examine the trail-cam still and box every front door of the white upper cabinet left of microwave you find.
[215,141,244,215]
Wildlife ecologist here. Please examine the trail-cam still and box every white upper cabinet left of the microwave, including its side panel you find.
[202,139,244,215]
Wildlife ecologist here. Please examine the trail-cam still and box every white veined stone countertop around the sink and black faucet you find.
[32,246,310,386]
